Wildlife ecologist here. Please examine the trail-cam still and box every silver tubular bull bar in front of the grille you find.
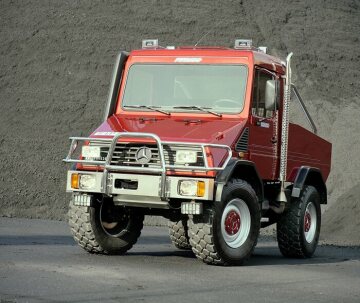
[63,132,232,200]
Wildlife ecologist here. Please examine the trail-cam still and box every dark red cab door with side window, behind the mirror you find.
[249,68,279,180]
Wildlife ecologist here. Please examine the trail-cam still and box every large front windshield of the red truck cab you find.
[122,64,247,114]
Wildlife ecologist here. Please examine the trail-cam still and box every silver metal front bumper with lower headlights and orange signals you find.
[66,170,214,208]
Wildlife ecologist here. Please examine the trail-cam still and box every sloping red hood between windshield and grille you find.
[91,116,246,145]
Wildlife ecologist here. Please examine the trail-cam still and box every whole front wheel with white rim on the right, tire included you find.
[188,179,261,265]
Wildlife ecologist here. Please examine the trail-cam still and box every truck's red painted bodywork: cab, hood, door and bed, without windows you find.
[88,48,331,181]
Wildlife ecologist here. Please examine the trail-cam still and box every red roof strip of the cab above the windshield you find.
[129,46,285,74]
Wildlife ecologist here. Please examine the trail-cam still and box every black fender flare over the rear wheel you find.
[291,166,327,204]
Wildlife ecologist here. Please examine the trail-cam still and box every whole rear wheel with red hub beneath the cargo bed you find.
[277,186,321,258]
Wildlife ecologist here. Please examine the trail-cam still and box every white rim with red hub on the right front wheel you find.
[221,199,251,248]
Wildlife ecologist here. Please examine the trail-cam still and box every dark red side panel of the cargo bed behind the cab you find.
[287,123,332,181]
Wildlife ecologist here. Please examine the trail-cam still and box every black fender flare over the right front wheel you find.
[215,158,264,203]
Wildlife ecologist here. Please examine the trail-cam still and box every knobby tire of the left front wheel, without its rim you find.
[68,202,144,254]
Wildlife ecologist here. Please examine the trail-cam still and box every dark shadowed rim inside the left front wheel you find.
[99,202,130,238]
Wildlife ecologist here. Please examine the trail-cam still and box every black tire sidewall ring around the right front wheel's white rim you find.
[213,180,261,265]
